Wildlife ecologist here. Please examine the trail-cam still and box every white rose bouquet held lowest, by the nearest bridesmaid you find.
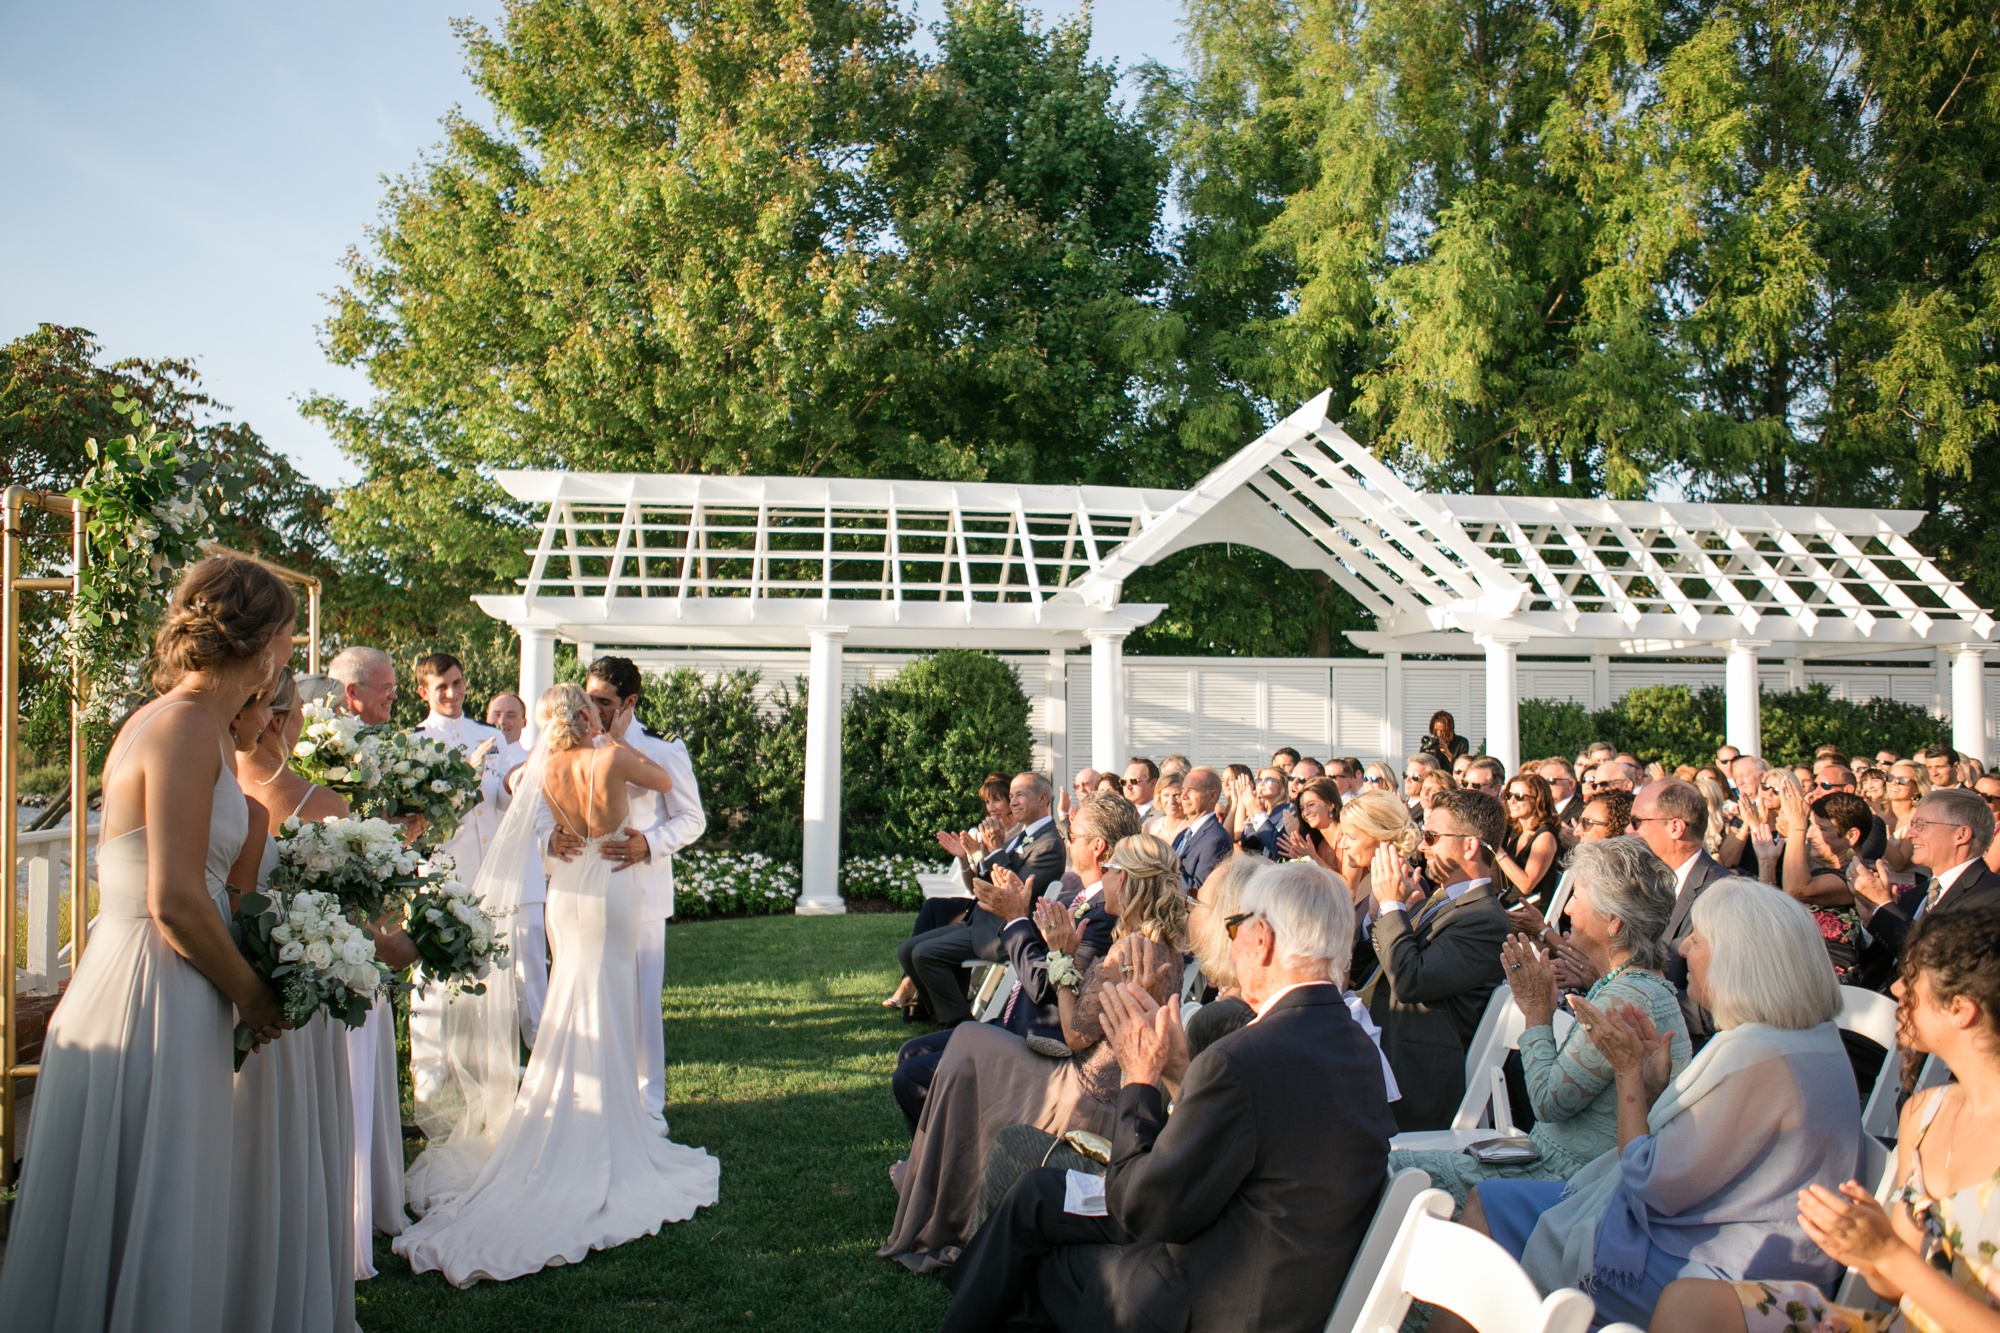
[230,891,390,1069]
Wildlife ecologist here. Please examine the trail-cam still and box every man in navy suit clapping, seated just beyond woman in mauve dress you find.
[890,791,1138,1135]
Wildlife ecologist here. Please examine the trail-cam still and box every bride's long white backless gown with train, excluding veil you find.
[394,740,720,1287]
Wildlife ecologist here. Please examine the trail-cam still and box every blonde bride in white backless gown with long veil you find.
[394,685,720,1287]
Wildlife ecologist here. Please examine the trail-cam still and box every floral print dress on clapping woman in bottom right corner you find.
[1730,1089,2000,1333]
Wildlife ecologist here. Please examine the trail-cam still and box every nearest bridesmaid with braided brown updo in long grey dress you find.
[0,556,296,1333]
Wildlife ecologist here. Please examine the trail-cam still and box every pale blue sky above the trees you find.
[0,0,1178,484]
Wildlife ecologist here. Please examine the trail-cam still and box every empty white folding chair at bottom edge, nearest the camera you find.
[1328,1189,1596,1333]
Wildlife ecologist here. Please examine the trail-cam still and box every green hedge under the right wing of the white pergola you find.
[1520,685,1950,769]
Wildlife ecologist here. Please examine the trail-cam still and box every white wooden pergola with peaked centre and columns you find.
[476,394,1994,913]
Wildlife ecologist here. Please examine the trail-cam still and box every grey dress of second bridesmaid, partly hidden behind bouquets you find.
[220,787,354,1333]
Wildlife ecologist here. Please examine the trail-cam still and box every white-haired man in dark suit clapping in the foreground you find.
[944,867,1394,1333]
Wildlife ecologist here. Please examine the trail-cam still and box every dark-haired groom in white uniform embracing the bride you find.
[546,656,708,1133]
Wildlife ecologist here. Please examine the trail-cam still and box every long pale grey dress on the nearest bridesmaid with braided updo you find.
[0,703,250,1333]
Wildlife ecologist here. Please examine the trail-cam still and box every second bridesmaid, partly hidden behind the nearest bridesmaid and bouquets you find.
[220,669,354,1333]
